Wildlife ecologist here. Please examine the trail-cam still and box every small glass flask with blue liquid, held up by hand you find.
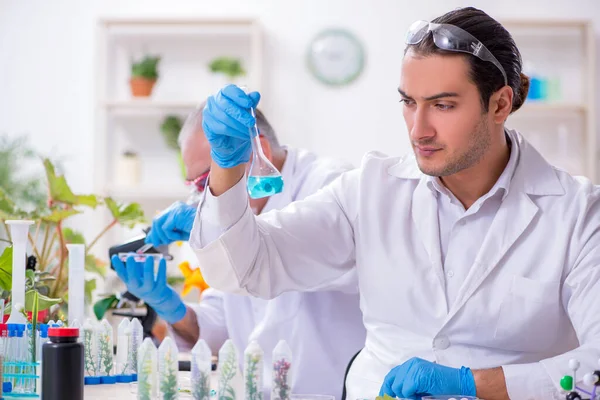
[241,87,283,199]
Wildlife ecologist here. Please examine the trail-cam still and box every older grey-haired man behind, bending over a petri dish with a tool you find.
[113,104,365,399]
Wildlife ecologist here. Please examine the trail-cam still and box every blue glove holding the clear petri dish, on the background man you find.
[111,255,186,324]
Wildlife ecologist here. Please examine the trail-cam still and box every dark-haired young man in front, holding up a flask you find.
[190,8,600,400]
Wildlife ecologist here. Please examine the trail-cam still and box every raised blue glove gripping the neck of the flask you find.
[202,85,260,168]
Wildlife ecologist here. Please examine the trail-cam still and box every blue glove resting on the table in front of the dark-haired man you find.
[379,358,476,399]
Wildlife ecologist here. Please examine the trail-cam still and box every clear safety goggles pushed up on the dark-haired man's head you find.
[406,21,508,85]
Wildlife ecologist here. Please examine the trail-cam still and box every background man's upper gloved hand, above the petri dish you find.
[144,201,196,247]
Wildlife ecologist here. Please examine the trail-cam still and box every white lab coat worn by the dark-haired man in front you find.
[192,131,600,400]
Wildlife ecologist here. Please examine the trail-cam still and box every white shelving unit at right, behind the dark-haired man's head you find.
[502,19,598,183]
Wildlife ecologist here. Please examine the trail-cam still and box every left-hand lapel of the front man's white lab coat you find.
[411,178,448,310]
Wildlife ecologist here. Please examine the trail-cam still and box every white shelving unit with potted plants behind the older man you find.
[94,18,262,251]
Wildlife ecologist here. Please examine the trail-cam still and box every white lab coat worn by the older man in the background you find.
[171,148,366,399]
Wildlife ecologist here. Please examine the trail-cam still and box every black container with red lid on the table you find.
[42,328,84,400]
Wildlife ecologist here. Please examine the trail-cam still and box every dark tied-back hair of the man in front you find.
[405,7,529,112]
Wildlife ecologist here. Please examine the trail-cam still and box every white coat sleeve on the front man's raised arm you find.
[190,170,359,298]
